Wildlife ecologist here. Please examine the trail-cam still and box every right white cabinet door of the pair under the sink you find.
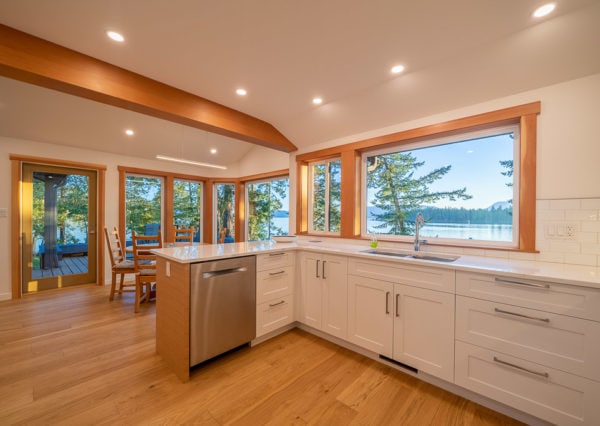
[393,284,454,382]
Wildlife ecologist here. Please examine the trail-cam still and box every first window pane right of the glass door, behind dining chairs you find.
[125,175,163,240]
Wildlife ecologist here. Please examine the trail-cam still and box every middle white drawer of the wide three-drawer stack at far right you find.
[456,296,600,381]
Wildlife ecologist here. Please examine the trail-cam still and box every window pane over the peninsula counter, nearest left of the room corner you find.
[247,178,290,241]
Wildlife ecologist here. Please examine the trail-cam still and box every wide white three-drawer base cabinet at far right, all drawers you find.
[455,272,600,425]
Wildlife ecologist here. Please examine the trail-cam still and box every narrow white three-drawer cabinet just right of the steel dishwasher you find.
[256,252,296,337]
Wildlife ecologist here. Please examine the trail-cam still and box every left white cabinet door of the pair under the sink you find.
[348,275,394,357]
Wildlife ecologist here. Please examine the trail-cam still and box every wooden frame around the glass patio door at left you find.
[9,154,106,299]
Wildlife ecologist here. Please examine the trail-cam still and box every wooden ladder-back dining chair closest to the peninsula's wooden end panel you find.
[131,230,162,313]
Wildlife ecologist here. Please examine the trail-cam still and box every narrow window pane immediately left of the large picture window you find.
[309,159,342,233]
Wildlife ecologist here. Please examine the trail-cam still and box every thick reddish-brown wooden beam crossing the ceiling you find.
[0,24,297,152]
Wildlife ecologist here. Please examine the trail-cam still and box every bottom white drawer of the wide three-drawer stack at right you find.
[455,341,600,425]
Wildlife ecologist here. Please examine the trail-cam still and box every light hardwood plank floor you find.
[0,286,520,425]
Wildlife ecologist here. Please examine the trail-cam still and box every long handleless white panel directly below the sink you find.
[348,258,454,293]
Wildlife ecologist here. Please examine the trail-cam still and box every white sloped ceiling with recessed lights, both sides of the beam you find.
[0,0,600,163]
